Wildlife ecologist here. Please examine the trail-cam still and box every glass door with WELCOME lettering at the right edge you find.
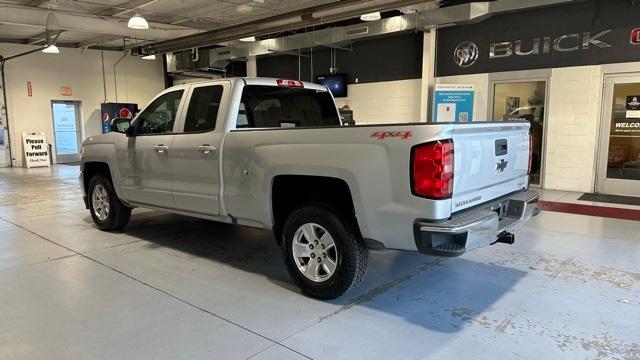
[598,75,640,196]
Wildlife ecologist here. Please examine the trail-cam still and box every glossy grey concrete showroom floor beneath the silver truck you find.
[0,165,640,360]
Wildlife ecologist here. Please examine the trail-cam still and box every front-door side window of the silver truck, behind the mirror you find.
[136,90,184,135]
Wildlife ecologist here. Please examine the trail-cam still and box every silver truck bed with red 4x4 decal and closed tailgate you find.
[221,122,529,250]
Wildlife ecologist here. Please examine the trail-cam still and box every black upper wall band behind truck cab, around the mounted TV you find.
[257,33,422,84]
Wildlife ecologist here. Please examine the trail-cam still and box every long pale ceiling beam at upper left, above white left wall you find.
[0,4,199,41]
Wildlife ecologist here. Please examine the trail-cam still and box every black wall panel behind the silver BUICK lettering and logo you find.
[436,0,640,76]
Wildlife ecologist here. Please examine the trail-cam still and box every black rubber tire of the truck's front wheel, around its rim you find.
[87,174,131,231]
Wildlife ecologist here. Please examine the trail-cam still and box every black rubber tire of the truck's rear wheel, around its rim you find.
[282,204,369,299]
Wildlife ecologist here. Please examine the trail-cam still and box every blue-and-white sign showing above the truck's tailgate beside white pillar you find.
[433,84,475,122]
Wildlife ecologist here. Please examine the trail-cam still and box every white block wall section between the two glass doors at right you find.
[544,66,603,192]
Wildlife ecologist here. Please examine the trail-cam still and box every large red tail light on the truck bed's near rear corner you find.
[411,140,453,199]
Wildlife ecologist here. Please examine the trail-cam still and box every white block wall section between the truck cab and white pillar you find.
[336,79,422,125]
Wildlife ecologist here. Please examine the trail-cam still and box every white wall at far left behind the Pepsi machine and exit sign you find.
[0,44,164,166]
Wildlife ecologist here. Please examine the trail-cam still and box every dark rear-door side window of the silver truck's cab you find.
[184,85,224,133]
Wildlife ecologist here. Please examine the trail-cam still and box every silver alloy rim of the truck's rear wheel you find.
[291,223,338,282]
